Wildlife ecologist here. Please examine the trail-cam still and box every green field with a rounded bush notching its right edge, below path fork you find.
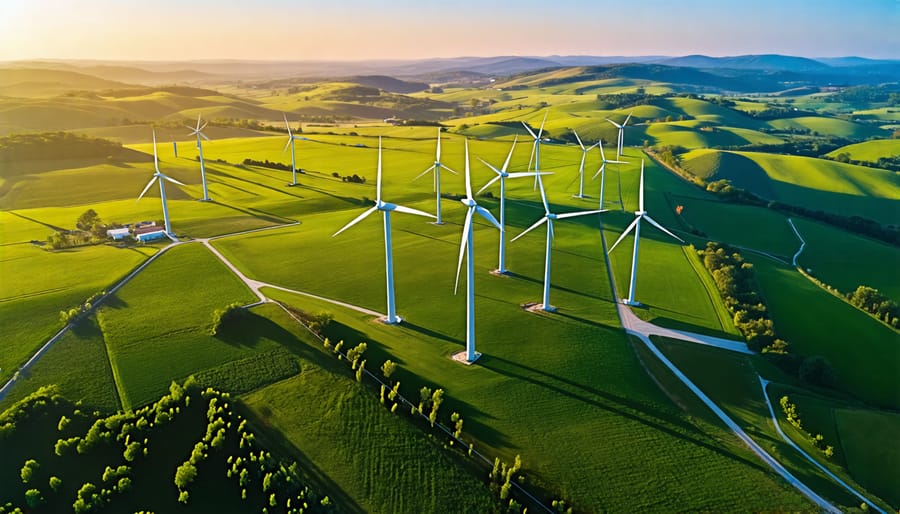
[97,244,265,409]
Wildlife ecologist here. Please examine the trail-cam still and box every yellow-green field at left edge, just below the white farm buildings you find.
[0,239,155,380]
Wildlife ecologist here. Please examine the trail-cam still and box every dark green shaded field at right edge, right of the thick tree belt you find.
[746,255,900,409]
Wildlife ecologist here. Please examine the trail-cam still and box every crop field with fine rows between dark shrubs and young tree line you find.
[243,309,492,513]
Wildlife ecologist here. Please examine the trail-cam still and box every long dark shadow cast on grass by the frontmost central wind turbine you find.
[479,355,768,472]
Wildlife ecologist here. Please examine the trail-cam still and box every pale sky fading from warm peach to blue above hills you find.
[0,0,900,60]
